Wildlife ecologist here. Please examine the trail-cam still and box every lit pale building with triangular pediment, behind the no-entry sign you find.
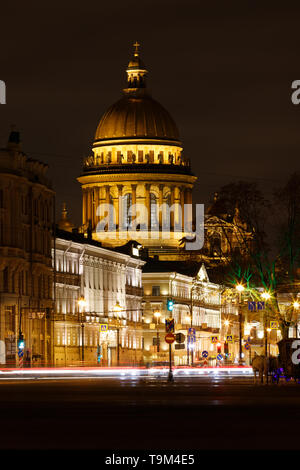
[143,261,221,365]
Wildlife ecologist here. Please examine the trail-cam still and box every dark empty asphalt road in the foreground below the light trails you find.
[0,377,300,450]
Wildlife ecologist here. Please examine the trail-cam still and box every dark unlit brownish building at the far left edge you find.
[0,131,54,365]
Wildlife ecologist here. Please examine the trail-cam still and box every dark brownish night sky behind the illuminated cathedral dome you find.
[0,0,300,224]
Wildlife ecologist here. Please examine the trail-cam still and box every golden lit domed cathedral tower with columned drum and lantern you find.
[78,43,197,259]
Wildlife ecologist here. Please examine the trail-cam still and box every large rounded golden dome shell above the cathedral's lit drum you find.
[95,93,180,142]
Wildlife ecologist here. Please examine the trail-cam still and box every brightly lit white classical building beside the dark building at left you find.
[53,229,144,366]
